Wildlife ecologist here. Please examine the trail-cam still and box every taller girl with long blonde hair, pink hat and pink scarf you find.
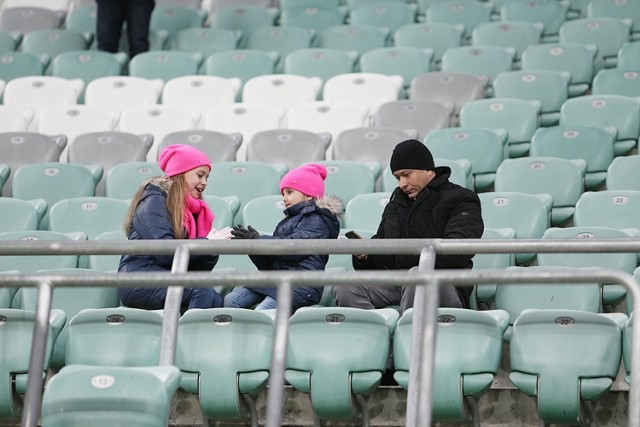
[118,144,232,310]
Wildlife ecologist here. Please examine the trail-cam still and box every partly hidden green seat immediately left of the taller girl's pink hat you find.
[104,162,163,200]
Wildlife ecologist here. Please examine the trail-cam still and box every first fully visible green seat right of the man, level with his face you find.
[495,157,587,225]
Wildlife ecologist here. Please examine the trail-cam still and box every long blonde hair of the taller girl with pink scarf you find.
[124,173,186,239]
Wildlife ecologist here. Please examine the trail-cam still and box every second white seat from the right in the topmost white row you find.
[242,74,322,117]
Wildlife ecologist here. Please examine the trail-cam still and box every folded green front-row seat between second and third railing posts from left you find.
[176,310,274,423]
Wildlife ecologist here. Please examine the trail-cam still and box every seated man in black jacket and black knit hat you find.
[334,139,484,312]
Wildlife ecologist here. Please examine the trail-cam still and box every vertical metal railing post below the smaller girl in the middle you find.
[265,280,292,427]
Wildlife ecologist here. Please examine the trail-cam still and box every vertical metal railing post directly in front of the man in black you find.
[406,246,439,427]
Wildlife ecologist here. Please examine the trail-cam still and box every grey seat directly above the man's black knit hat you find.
[374,99,454,140]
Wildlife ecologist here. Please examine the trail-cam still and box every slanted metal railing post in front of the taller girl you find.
[160,245,189,366]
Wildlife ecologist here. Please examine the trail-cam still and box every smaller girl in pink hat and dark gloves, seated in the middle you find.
[224,164,342,311]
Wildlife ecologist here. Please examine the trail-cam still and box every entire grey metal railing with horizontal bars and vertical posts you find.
[0,238,640,427]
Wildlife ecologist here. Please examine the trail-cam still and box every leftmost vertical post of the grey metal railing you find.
[21,280,53,427]
